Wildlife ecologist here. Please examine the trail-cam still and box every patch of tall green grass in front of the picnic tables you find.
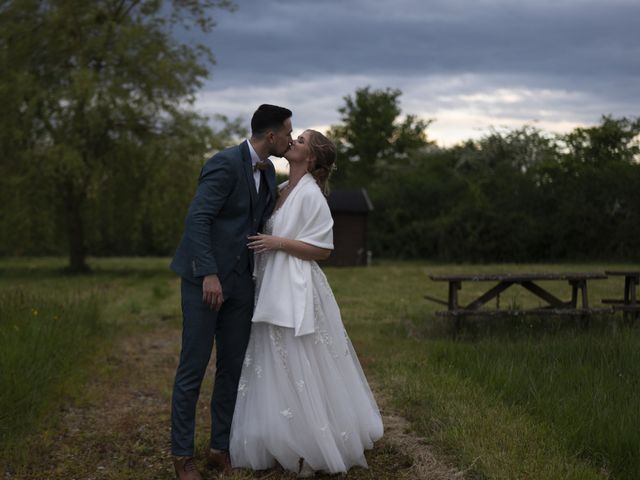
[428,328,640,479]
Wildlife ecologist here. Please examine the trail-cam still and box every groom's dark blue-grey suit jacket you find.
[171,141,276,283]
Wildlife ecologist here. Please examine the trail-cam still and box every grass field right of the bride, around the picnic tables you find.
[328,264,640,479]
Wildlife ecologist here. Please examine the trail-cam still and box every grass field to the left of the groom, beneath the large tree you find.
[0,258,180,466]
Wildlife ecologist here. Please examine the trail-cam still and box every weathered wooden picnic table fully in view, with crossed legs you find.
[425,272,611,317]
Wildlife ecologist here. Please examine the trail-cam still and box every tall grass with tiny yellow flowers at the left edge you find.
[0,289,104,455]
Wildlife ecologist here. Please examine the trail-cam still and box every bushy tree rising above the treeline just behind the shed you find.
[329,87,431,186]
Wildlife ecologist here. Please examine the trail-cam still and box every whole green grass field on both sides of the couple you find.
[0,259,640,479]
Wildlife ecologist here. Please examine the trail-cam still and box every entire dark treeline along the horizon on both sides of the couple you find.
[0,89,640,262]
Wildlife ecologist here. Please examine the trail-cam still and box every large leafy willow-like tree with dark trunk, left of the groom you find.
[0,0,232,272]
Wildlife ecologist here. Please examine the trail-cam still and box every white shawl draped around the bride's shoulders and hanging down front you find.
[252,173,333,336]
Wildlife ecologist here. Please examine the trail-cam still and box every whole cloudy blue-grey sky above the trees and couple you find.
[195,0,640,146]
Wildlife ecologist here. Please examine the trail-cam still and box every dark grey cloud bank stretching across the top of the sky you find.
[212,1,640,75]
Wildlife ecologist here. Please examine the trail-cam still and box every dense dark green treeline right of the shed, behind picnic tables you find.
[369,117,640,262]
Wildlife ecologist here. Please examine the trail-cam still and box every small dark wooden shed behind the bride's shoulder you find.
[323,189,373,266]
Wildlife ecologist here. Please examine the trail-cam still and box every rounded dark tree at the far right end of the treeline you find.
[548,116,640,260]
